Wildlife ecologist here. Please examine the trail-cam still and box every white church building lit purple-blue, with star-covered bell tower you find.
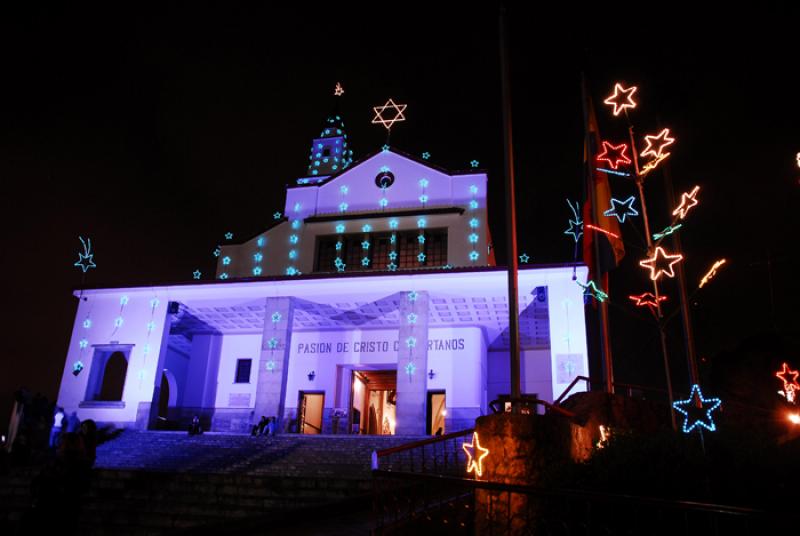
[53,112,588,435]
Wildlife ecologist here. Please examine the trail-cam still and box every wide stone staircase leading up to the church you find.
[0,430,419,536]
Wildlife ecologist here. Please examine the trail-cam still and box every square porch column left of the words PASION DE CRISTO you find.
[251,297,294,431]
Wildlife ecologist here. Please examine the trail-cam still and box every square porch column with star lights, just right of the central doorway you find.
[395,290,428,435]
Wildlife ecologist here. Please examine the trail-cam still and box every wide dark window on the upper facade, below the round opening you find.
[314,229,447,272]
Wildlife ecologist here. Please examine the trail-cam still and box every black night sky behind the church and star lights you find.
[0,2,800,432]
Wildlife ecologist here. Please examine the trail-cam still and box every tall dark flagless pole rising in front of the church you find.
[500,5,520,404]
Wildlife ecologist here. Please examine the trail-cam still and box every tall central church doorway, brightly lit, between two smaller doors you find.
[351,370,397,435]
